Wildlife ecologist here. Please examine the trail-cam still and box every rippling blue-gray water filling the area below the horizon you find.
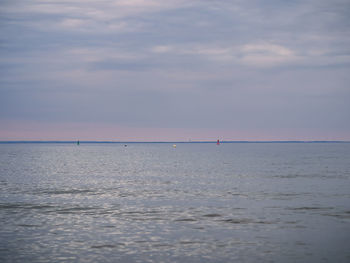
[0,143,350,262]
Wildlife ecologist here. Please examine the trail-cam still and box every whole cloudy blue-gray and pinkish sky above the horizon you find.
[0,0,350,141]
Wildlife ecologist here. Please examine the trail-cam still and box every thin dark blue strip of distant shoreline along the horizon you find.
[0,140,350,144]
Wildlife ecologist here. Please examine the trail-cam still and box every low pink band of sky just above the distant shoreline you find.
[0,121,350,141]
